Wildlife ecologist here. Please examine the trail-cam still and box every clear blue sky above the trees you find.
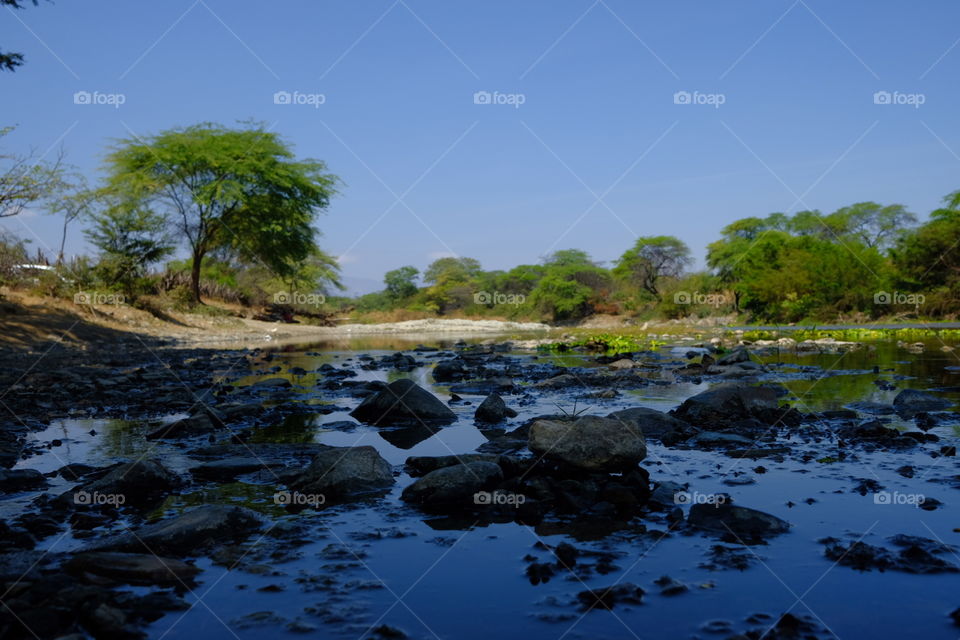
[0,0,960,290]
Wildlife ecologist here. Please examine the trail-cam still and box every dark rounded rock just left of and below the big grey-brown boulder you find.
[401,462,503,509]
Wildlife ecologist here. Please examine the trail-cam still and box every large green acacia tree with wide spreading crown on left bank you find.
[104,123,339,302]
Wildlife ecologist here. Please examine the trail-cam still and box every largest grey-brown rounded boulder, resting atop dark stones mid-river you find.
[527,416,647,472]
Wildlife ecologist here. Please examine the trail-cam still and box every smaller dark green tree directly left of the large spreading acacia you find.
[84,201,173,294]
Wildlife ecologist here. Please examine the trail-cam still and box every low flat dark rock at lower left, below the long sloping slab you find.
[64,551,200,586]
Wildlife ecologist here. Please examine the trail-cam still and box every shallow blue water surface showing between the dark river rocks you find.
[7,339,960,640]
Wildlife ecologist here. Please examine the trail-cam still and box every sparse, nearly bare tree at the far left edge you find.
[0,126,65,218]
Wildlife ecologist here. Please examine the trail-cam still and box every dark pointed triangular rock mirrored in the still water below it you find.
[350,378,457,426]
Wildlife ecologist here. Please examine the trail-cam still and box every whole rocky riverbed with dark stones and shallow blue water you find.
[0,339,960,640]
